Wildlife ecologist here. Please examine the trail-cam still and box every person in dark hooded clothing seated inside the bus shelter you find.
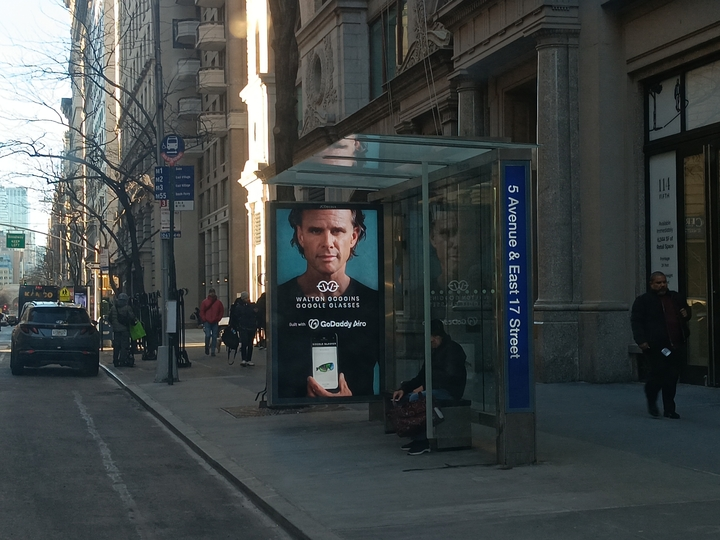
[393,319,467,456]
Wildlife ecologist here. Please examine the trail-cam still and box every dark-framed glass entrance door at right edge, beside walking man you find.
[677,144,720,386]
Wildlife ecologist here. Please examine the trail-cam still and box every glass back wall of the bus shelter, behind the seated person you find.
[389,165,496,412]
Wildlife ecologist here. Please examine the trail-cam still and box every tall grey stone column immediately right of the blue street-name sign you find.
[535,32,580,382]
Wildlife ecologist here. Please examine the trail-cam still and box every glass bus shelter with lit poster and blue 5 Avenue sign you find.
[266,134,535,466]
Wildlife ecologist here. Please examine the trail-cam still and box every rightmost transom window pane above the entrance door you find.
[685,60,720,129]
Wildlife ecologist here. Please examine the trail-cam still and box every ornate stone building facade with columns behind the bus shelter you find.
[250,0,720,384]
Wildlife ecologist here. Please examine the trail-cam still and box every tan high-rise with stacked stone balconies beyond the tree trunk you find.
[195,0,250,307]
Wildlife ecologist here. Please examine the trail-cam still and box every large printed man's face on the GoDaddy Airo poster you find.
[297,209,359,275]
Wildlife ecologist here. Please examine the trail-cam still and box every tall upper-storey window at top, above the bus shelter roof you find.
[370,0,407,99]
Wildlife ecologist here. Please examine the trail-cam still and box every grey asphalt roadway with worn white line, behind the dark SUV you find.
[0,328,288,540]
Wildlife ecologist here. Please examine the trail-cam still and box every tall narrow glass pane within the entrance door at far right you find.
[683,154,709,366]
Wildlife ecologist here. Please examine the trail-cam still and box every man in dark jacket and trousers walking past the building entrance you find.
[630,272,690,419]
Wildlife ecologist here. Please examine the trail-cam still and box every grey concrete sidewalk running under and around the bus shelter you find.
[101,329,720,540]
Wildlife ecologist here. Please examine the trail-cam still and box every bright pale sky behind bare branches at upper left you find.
[0,0,71,244]
